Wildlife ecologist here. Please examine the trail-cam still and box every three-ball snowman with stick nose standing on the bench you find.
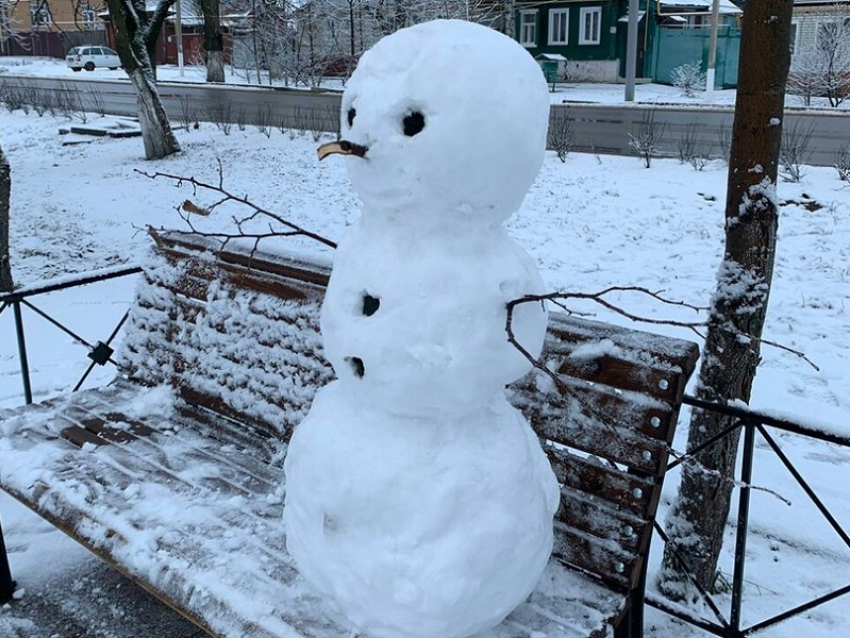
[284,21,559,638]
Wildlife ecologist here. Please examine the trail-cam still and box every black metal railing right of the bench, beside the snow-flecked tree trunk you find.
[644,395,850,638]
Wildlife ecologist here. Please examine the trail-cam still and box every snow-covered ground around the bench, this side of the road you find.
[0,91,850,638]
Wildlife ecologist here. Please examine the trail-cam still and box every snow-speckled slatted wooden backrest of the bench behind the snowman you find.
[122,233,698,590]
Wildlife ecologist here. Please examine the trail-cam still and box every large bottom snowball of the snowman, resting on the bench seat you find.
[284,382,559,638]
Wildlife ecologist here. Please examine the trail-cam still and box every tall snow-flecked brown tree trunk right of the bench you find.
[659,0,792,600]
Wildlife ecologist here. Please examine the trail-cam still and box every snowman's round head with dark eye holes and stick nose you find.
[320,20,549,226]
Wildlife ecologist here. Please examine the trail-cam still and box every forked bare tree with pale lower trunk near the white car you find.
[106,0,180,159]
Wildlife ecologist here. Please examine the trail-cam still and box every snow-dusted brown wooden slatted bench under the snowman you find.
[0,233,697,638]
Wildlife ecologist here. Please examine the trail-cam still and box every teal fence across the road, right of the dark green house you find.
[649,27,741,89]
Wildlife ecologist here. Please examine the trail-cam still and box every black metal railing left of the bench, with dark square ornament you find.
[0,266,142,404]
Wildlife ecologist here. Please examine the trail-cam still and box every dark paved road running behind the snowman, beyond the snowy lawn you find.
[2,76,850,166]
